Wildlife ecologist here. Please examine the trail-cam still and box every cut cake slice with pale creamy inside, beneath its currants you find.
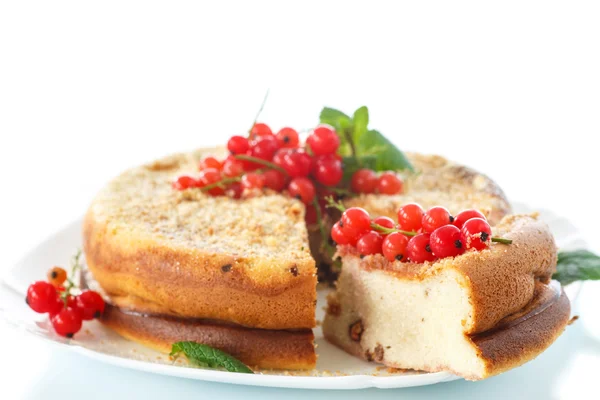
[323,215,570,380]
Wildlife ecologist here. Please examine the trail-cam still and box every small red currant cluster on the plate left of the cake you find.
[25,255,105,338]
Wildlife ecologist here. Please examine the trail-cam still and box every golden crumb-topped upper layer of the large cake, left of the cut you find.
[83,149,317,329]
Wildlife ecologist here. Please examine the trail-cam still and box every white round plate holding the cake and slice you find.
[0,204,586,389]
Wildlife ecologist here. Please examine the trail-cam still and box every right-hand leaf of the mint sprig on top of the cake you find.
[356,129,414,172]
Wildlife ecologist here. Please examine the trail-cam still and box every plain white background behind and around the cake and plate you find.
[0,1,600,398]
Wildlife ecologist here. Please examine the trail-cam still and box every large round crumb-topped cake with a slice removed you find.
[83,148,510,369]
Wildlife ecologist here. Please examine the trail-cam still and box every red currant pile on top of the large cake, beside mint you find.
[173,123,402,212]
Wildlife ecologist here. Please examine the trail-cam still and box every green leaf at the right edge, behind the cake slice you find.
[552,250,600,285]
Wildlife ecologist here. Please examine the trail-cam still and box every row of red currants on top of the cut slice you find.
[331,203,511,263]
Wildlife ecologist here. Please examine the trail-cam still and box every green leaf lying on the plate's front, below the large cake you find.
[171,342,254,374]
